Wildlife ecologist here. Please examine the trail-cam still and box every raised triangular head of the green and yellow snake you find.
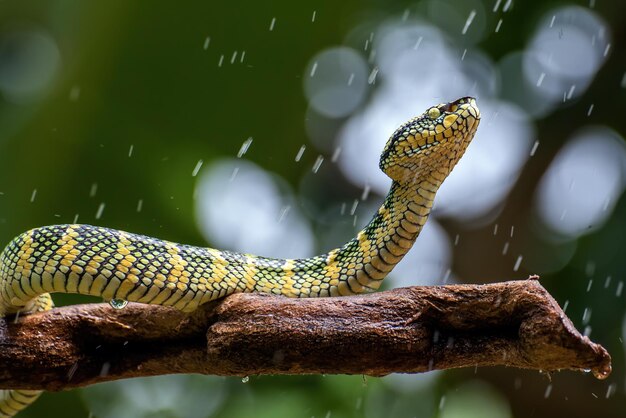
[380,97,480,186]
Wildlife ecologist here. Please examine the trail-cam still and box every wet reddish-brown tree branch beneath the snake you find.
[0,280,611,390]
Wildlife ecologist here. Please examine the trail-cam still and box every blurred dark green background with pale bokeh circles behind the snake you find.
[0,0,626,418]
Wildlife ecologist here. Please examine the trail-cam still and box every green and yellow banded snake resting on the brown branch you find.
[0,97,480,417]
